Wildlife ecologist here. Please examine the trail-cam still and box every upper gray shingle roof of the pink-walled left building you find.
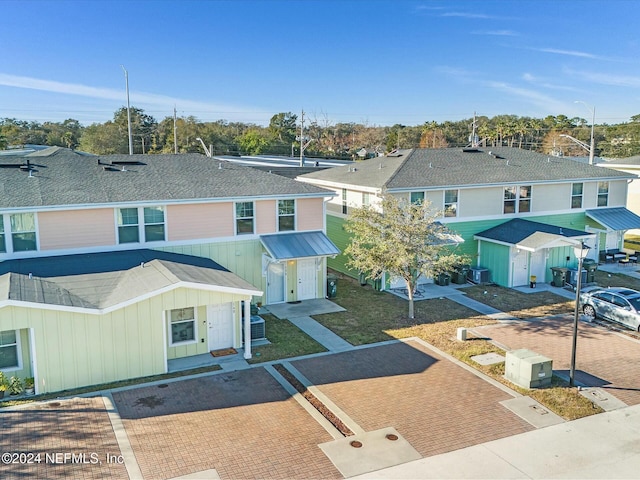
[0,151,330,208]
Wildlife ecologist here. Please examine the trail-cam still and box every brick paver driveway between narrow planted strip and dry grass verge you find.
[292,342,533,456]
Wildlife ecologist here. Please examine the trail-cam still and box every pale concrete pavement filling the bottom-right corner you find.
[352,405,640,479]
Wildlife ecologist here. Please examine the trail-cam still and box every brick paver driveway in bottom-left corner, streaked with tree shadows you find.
[0,397,129,480]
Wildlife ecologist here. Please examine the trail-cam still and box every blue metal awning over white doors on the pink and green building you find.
[260,231,340,260]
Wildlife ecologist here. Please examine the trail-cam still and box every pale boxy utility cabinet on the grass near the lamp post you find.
[505,348,553,388]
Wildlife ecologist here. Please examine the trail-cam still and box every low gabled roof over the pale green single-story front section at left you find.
[0,249,259,309]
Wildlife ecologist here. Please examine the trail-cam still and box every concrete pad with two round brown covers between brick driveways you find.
[319,427,422,478]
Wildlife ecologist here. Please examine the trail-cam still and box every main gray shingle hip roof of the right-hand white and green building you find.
[301,147,635,191]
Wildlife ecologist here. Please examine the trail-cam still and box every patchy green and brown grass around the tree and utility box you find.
[314,275,602,420]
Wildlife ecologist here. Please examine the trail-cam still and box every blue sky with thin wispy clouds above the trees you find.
[0,0,640,126]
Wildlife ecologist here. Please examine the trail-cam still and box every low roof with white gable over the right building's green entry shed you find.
[474,218,594,252]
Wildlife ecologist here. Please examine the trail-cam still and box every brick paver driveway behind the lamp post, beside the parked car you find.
[475,315,640,405]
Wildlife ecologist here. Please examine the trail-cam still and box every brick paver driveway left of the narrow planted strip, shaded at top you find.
[113,368,342,479]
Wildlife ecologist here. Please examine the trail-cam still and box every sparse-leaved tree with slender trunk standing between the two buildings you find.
[344,194,469,318]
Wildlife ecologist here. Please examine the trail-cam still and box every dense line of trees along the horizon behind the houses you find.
[0,107,640,159]
